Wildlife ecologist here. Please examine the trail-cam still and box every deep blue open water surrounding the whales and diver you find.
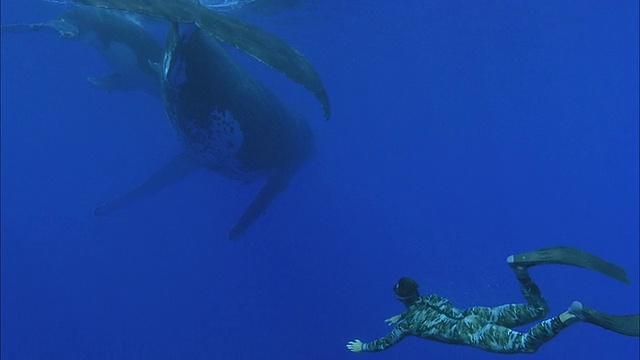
[1,0,640,359]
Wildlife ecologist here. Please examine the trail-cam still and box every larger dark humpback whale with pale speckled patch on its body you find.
[75,0,329,239]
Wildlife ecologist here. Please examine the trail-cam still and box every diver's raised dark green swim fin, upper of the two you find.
[507,246,630,284]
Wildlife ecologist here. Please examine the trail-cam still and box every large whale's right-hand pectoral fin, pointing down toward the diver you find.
[229,169,294,240]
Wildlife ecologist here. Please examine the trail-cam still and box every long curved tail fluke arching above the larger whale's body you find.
[75,0,331,119]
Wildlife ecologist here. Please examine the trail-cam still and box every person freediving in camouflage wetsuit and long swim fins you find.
[347,247,640,354]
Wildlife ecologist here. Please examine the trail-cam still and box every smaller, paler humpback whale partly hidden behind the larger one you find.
[1,6,163,98]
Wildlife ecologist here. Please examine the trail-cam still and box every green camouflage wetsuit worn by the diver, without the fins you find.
[362,275,567,354]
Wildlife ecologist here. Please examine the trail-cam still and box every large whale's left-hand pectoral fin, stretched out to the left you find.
[93,151,201,216]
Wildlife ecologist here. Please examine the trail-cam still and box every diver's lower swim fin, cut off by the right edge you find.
[569,301,640,336]
